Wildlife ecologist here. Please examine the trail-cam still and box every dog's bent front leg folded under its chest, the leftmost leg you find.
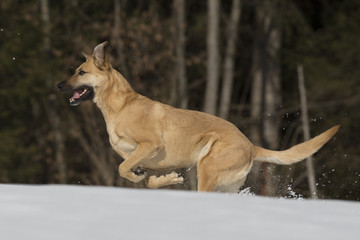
[119,142,164,182]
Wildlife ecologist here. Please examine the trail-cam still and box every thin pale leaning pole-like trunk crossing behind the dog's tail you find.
[297,65,318,199]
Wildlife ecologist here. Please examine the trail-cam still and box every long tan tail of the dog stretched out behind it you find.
[253,125,340,165]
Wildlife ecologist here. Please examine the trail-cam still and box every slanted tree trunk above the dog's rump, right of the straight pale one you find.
[219,0,241,119]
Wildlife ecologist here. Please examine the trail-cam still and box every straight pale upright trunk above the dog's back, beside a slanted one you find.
[204,0,220,114]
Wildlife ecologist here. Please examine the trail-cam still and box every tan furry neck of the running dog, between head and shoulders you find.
[94,68,138,116]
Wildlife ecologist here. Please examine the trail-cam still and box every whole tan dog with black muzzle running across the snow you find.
[57,42,339,192]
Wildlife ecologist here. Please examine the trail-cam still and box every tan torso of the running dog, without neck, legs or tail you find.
[99,90,252,170]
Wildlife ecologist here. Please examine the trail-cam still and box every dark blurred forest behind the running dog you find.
[0,0,360,201]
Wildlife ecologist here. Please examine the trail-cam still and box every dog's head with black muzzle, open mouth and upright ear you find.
[56,41,111,106]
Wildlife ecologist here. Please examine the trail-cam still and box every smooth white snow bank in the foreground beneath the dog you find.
[0,184,360,240]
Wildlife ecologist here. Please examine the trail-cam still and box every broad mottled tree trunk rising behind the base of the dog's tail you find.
[251,0,281,196]
